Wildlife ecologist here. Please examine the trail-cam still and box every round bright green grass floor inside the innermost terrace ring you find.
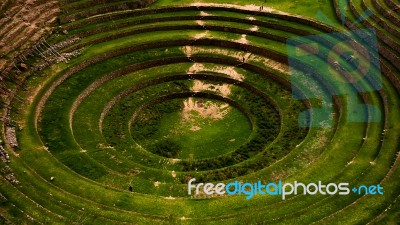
[138,99,251,159]
